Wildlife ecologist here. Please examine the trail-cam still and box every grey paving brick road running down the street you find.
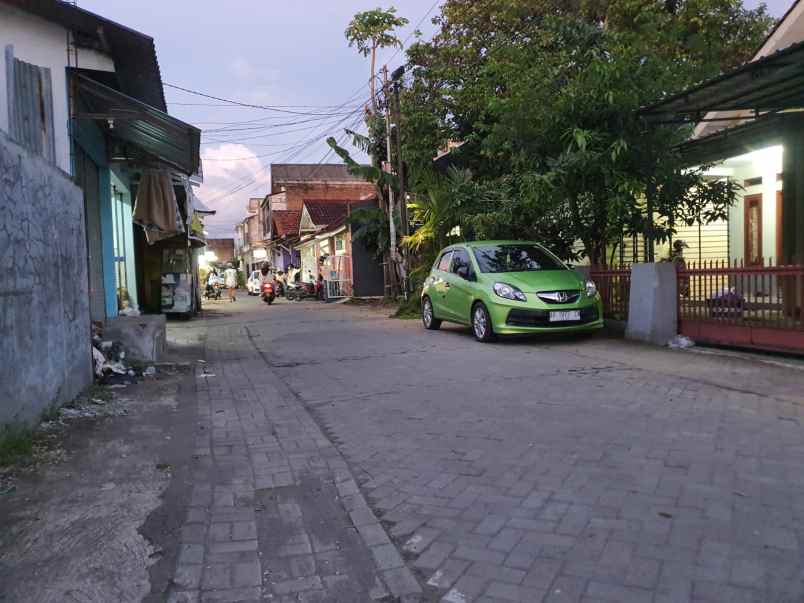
[165,299,804,603]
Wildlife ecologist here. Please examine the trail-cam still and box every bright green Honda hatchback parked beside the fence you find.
[421,241,603,342]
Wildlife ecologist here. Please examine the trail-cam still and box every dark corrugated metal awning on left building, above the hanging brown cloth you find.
[72,71,201,176]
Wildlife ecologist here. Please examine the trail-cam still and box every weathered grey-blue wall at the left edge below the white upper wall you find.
[0,131,92,424]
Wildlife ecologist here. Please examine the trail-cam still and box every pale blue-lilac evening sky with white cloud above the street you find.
[78,0,792,237]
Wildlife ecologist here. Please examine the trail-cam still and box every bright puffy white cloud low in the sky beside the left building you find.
[197,144,269,238]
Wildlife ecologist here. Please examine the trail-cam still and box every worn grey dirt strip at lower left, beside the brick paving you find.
[0,367,186,603]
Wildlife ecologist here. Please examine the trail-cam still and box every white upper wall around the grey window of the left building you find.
[0,4,115,172]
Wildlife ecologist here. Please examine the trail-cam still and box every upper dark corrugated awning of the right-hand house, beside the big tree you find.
[639,42,804,123]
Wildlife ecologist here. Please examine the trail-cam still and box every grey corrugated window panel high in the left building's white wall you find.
[5,45,56,164]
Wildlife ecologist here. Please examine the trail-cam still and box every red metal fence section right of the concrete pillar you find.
[678,260,804,352]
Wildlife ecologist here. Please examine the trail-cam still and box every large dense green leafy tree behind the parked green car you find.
[402,0,770,263]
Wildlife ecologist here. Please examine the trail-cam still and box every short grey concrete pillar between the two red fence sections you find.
[625,262,678,345]
